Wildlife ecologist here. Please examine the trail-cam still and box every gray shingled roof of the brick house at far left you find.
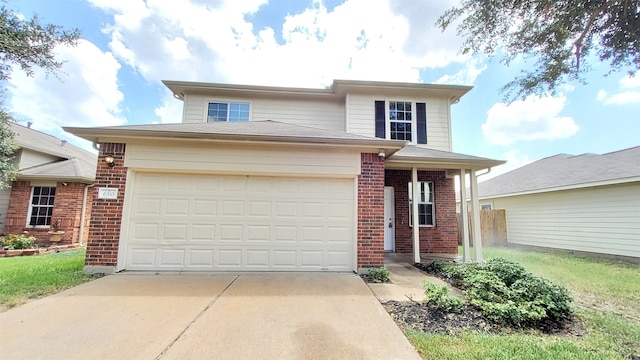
[10,123,98,183]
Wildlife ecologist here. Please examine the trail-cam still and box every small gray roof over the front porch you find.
[388,145,504,169]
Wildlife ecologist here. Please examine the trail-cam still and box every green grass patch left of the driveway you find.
[0,249,91,308]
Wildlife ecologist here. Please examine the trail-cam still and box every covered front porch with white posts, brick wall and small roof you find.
[384,145,504,263]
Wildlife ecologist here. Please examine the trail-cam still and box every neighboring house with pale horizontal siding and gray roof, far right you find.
[470,146,640,258]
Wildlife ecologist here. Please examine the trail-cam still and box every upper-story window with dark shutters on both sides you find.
[375,100,427,144]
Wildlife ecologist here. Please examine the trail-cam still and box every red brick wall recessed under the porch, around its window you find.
[385,170,458,255]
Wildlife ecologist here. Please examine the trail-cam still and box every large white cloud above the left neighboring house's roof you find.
[8,40,126,145]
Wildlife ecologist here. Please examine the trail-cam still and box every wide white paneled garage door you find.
[124,173,355,271]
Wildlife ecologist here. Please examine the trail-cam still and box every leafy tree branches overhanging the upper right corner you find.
[436,0,640,101]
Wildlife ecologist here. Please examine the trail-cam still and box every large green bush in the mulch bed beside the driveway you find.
[444,258,572,326]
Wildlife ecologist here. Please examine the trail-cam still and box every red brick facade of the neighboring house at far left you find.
[5,181,90,245]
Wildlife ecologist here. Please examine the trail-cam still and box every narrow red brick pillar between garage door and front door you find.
[358,154,384,268]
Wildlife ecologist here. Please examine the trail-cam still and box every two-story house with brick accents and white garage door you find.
[65,80,502,272]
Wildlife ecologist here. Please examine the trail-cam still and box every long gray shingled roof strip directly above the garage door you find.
[64,120,406,149]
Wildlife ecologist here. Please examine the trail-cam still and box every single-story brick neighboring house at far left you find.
[0,123,97,244]
